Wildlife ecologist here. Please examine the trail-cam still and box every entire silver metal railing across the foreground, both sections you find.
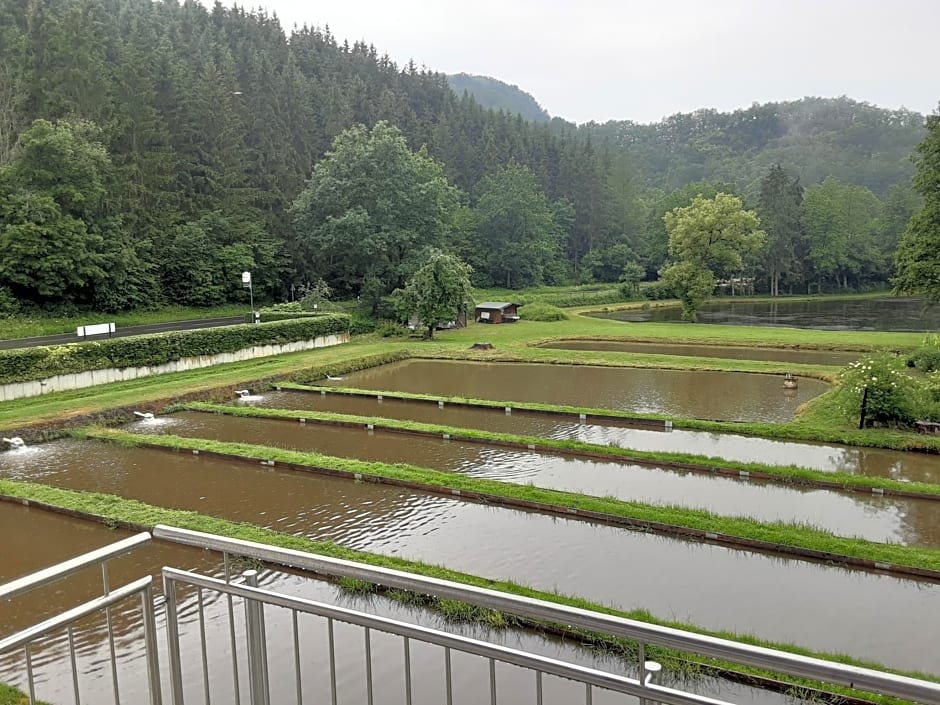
[0,526,940,705]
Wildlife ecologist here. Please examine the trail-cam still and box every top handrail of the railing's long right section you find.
[153,524,940,705]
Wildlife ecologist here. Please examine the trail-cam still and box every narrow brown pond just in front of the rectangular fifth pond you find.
[255,391,940,483]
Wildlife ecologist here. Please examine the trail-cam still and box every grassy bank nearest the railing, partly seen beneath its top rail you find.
[0,480,940,705]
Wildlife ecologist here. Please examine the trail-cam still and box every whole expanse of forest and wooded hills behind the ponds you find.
[0,0,924,315]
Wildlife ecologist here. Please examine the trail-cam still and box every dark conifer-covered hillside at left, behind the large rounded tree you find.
[0,0,629,310]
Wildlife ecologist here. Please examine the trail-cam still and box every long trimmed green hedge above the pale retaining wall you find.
[0,314,349,384]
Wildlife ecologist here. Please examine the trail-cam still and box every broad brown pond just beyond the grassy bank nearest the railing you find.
[0,441,940,673]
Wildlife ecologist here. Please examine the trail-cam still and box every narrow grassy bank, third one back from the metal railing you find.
[176,402,940,500]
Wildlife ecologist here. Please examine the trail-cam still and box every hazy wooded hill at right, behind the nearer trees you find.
[581,97,924,195]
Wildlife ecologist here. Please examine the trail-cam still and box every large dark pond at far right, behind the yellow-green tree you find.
[592,296,940,331]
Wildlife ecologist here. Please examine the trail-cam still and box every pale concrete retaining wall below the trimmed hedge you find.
[0,333,349,401]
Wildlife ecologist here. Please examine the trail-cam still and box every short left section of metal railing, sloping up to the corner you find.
[0,533,162,705]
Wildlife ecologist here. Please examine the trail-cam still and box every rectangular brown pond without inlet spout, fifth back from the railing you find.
[320,360,828,422]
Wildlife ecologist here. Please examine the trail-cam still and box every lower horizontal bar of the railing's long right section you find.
[163,568,729,705]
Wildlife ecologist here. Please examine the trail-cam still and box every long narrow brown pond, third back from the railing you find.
[141,412,940,547]
